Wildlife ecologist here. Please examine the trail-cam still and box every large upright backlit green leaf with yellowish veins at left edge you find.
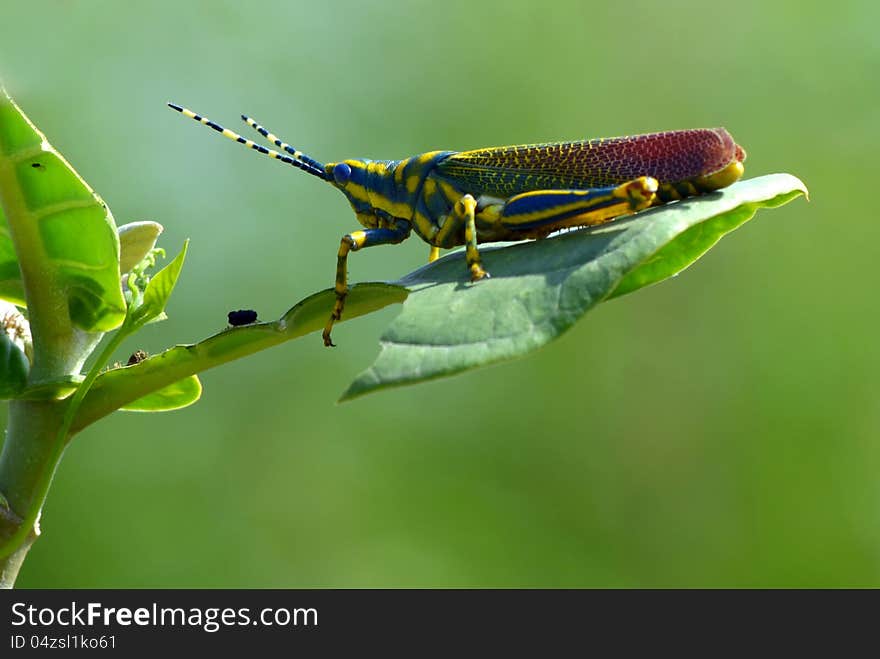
[0,90,125,336]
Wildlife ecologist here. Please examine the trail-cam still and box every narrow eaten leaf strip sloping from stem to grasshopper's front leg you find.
[72,283,407,432]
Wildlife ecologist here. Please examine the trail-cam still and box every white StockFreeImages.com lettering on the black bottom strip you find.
[12,602,318,633]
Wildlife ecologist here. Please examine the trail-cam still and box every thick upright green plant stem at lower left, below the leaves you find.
[0,400,66,588]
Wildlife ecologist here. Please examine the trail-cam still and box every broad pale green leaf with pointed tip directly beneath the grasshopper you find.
[342,174,806,400]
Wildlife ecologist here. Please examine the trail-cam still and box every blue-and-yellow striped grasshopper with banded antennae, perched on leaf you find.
[168,103,745,346]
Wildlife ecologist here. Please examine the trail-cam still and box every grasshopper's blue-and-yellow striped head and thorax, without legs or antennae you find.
[324,151,455,230]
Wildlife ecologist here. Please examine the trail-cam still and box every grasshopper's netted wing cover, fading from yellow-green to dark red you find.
[438,128,745,197]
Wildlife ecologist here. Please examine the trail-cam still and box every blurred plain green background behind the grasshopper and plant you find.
[0,0,880,587]
